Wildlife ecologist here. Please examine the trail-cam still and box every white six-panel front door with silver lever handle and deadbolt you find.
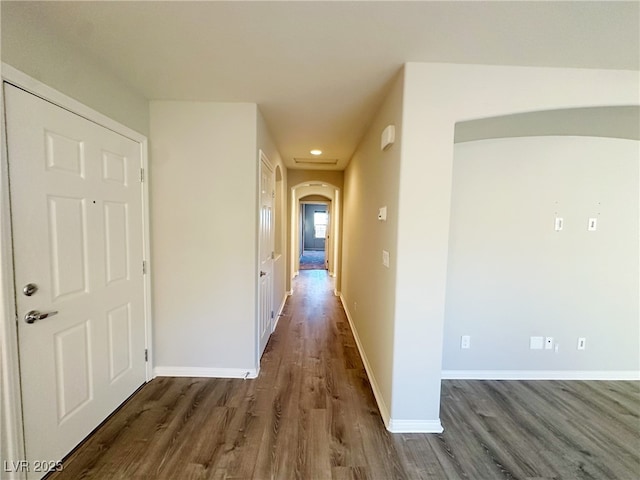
[4,83,146,478]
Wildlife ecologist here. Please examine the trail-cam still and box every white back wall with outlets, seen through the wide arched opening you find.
[443,136,640,376]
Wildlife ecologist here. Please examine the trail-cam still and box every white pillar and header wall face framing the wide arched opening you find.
[391,63,640,429]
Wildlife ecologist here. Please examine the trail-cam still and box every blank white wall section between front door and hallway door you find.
[150,101,257,376]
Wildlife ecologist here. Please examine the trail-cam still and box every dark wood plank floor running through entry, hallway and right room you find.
[49,270,640,480]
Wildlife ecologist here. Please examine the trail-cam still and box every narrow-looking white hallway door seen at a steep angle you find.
[258,152,274,356]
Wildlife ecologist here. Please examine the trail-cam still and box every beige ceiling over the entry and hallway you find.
[2,0,640,169]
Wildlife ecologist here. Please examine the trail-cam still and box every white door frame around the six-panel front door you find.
[0,63,153,468]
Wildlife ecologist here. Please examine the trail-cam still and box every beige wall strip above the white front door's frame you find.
[0,2,149,136]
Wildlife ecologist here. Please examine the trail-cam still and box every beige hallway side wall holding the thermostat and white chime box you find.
[342,70,403,424]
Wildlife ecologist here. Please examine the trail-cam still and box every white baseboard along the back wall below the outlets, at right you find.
[442,370,640,380]
